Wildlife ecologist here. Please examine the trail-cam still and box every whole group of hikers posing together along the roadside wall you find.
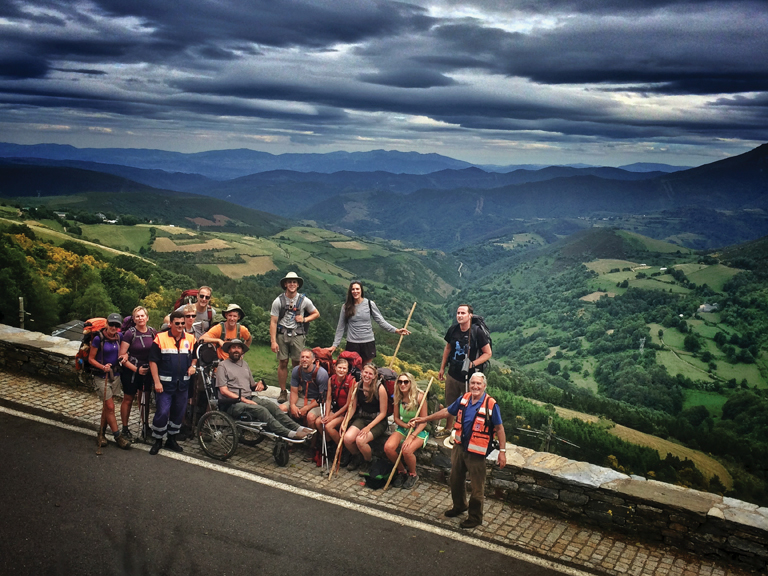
[87,272,506,528]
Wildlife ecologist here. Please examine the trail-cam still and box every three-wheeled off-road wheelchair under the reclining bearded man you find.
[196,342,306,466]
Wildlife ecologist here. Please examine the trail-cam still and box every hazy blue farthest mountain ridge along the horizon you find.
[0,143,688,180]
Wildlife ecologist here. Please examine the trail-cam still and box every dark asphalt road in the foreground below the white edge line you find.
[0,413,559,576]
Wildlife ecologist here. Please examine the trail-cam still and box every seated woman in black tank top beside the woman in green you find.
[344,364,387,475]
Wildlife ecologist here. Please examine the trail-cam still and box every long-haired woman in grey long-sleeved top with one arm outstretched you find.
[331,281,410,366]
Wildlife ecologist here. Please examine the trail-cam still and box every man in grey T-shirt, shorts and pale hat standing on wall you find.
[269,272,320,404]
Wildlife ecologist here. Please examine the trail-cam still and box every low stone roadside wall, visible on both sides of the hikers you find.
[0,324,768,572]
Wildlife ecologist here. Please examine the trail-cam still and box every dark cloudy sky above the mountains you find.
[0,0,768,166]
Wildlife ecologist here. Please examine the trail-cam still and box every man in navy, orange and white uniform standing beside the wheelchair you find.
[149,310,197,456]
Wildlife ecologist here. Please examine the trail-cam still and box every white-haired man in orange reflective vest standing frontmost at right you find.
[408,372,507,528]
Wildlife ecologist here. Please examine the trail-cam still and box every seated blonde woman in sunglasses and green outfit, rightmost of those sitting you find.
[384,372,429,489]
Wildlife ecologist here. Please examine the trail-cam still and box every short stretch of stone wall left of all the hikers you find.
[0,324,85,390]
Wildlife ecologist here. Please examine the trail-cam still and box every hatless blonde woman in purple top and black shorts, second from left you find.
[120,306,157,441]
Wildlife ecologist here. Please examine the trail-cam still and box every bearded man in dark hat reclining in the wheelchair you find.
[216,338,314,440]
